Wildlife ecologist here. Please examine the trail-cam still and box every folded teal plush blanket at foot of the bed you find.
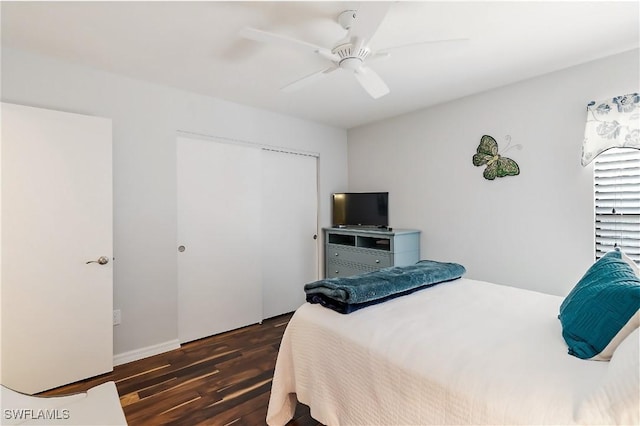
[304,260,466,304]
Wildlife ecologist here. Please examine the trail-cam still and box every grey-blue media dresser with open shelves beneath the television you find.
[324,228,420,278]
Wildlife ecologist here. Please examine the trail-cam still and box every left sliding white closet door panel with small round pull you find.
[177,137,262,342]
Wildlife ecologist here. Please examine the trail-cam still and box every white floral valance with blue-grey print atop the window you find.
[582,93,640,166]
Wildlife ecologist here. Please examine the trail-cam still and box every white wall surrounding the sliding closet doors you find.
[2,49,347,354]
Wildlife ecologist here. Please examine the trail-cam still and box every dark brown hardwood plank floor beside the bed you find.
[43,314,321,426]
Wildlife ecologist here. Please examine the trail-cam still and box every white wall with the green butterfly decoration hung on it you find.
[348,50,640,295]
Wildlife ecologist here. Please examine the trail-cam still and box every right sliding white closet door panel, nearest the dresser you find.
[262,151,318,318]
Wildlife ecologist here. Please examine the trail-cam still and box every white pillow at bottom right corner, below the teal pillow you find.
[576,330,640,425]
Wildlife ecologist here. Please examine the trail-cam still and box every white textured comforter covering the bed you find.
[267,278,637,426]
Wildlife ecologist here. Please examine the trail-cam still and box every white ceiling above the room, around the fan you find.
[1,1,640,128]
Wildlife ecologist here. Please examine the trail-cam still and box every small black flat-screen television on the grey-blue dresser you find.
[333,192,389,228]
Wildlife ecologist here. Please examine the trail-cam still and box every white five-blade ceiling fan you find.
[240,2,466,99]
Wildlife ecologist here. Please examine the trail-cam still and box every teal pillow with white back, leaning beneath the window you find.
[558,251,640,360]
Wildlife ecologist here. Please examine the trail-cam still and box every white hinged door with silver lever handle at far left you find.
[1,103,113,394]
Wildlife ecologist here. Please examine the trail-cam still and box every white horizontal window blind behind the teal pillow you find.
[593,148,640,263]
